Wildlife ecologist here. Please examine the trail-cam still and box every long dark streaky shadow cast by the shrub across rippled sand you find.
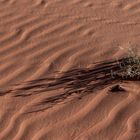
[1,58,137,112]
